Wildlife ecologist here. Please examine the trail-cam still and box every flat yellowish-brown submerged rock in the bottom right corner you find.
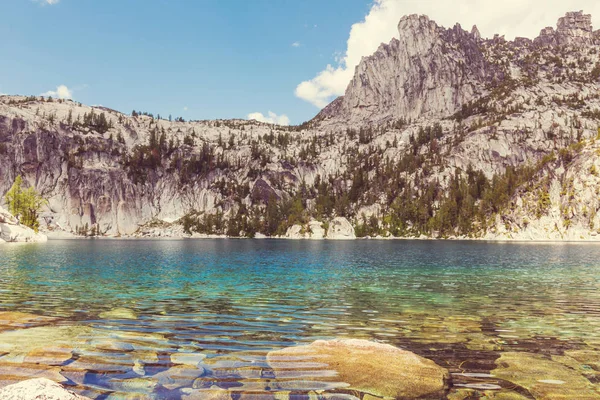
[492,352,600,400]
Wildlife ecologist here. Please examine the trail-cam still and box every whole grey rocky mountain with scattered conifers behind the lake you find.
[0,12,600,240]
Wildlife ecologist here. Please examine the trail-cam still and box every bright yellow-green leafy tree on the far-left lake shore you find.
[6,175,46,232]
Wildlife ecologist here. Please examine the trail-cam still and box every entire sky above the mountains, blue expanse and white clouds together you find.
[0,0,600,125]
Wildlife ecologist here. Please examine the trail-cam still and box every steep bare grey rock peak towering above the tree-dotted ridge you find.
[317,15,495,124]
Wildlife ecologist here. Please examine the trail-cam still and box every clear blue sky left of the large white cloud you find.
[0,0,371,124]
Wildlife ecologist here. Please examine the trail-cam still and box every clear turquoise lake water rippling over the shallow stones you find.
[0,240,600,399]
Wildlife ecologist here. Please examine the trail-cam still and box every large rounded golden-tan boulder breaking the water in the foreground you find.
[267,339,449,399]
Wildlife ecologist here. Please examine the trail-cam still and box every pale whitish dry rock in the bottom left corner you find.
[0,378,90,400]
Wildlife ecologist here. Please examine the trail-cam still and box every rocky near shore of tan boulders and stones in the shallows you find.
[0,308,600,400]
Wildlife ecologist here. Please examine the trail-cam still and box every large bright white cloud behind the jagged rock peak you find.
[295,0,600,108]
